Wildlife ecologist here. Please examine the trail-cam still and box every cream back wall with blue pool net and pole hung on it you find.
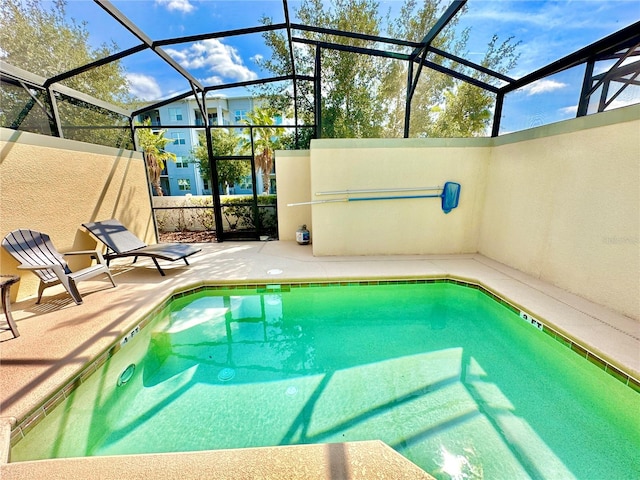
[311,139,491,255]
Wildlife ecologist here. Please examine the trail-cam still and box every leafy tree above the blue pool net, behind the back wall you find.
[383,7,519,137]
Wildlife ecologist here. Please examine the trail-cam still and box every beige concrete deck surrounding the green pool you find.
[0,241,640,480]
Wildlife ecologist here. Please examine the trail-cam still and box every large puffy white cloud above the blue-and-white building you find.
[166,39,258,82]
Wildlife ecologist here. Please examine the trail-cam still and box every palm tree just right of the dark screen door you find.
[242,107,284,193]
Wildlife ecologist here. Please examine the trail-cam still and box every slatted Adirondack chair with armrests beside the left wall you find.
[2,229,116,305]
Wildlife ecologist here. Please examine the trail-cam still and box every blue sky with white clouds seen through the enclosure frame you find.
[55,0,640,133]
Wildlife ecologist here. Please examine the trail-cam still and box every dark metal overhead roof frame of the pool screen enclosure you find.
[0,0,640,142]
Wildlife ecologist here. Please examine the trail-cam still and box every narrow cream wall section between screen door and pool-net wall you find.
[276,150,313,240]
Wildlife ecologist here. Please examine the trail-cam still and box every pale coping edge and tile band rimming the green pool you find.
[6,274,640,458]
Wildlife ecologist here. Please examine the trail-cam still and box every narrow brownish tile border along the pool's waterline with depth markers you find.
[10,277,640,447]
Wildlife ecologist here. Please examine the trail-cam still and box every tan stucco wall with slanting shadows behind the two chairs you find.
[0,128,155,300]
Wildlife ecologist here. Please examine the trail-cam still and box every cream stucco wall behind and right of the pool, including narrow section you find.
[277,105,640,319]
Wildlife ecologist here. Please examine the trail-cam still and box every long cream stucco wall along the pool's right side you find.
[478,106,640,318]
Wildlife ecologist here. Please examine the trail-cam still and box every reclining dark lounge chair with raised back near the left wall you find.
[82,218,202,276]
